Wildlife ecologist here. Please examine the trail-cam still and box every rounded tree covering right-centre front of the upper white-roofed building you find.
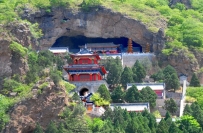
[140,86,157,108]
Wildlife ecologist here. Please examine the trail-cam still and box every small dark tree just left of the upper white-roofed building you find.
[111,86,125,103]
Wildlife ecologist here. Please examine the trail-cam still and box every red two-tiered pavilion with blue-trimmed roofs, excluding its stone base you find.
[64,48,107,81]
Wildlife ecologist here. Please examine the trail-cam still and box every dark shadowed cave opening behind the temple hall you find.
[52,36,142,53]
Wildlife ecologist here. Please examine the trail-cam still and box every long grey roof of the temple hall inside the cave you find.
[79,42,120,48]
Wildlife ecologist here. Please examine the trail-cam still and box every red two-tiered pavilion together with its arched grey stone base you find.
[63,47,108,96]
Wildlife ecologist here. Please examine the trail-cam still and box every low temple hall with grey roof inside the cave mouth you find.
[79,42,120,54]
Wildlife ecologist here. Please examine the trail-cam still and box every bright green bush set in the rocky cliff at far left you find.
[9,42,27,57]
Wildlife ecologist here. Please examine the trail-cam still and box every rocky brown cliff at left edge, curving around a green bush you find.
[0,22,36,89]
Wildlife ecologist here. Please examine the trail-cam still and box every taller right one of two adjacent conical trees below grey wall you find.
[132,60,146,83]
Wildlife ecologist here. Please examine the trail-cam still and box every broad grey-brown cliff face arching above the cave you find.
[22,7,166,52]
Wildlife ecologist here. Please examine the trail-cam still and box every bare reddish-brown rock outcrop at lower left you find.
[4,82,67,133]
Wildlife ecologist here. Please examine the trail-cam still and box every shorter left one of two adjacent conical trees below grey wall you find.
[121,67,133,88]
